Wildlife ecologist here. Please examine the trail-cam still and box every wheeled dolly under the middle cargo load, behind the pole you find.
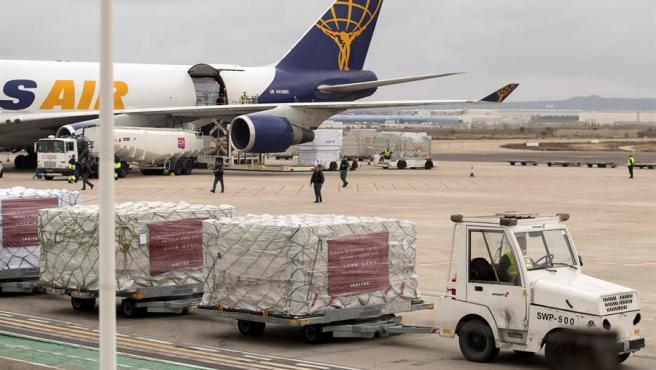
[47,283,203,318]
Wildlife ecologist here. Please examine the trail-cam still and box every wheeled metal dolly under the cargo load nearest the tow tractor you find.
[195,301,438,344]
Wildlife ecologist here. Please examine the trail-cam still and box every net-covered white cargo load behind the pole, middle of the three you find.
[39,202,237,291]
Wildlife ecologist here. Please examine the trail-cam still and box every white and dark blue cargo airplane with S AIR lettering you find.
[0,0,517,168]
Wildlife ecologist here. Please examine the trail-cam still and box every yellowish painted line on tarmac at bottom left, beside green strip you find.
[0,318,320,370]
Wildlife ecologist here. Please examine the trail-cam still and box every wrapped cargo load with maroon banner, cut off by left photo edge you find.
[0,187,80,275]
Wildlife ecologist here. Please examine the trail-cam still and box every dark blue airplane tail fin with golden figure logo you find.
[277,0,383,71]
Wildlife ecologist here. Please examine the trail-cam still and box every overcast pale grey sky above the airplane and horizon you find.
[0,0,656,101]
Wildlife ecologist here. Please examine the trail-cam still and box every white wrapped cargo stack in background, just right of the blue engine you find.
[298,129,344,167]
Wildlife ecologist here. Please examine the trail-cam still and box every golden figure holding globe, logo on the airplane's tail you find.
[316,0,383,71]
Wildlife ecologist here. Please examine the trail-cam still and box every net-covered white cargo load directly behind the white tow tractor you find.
[203,215,419,317]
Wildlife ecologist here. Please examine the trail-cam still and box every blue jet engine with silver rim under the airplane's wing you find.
[230,115,314,153]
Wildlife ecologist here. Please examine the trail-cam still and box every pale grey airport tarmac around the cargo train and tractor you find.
[0,161,656,370]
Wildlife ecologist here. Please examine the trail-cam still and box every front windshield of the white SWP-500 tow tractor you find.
[515,229,576,271]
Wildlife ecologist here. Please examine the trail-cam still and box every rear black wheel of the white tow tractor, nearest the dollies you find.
[458,320,499,362]
